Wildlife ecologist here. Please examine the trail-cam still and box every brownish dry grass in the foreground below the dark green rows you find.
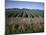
[6,17,44,33]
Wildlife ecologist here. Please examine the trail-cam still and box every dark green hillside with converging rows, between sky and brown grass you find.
[5,8,44,17]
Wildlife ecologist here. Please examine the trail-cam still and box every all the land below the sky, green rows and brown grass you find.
[5,8,44,34]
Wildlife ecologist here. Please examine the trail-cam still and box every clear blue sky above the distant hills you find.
[5,0,44,10]
